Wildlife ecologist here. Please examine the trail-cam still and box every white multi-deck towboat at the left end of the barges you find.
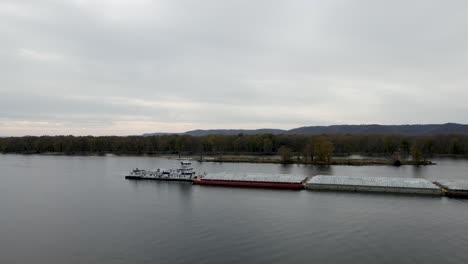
[125,161,196,182]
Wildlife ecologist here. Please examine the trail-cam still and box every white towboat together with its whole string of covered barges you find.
[125,165,468,198]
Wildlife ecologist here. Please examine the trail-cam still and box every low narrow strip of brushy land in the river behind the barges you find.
[198,156,435,166]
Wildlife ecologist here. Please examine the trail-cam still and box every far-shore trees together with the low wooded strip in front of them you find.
[0,134,468,165]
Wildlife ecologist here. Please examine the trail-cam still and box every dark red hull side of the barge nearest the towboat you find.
[193,179,304,190]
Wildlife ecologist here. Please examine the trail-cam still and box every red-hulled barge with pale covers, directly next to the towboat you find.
[193,173,307,190]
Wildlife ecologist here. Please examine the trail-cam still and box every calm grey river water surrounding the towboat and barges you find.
[0,155,468,264]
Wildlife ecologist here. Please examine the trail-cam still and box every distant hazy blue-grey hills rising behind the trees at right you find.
[144,123,468,136]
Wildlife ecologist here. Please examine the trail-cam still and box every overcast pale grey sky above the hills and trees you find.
[0,0,468,136]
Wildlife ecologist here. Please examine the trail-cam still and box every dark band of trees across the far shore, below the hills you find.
[0,134,468,158]
